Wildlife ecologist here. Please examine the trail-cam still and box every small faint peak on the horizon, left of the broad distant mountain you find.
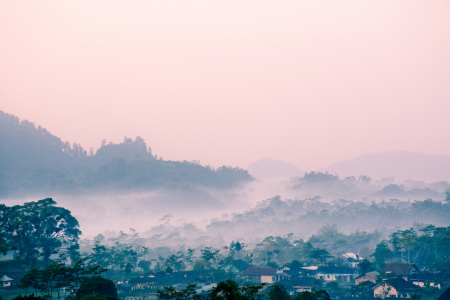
[247,158,305,179]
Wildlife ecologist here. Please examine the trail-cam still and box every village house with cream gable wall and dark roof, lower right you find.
[373,277,420,299]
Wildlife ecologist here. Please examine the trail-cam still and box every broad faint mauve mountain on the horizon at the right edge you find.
[319,151,450,182]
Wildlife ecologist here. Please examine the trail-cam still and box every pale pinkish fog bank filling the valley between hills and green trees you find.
[3,172,450,249]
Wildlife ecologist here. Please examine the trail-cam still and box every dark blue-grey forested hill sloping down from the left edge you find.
[0,111,253,198]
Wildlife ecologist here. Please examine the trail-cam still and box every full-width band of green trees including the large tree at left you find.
[0,198,450,288]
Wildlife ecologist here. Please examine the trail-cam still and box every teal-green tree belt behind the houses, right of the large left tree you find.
[82,225,450,274]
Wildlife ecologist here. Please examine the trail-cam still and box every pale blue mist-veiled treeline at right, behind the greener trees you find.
[205,196,450,244]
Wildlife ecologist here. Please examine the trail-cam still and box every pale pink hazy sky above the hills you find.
[0,0,450,170]
